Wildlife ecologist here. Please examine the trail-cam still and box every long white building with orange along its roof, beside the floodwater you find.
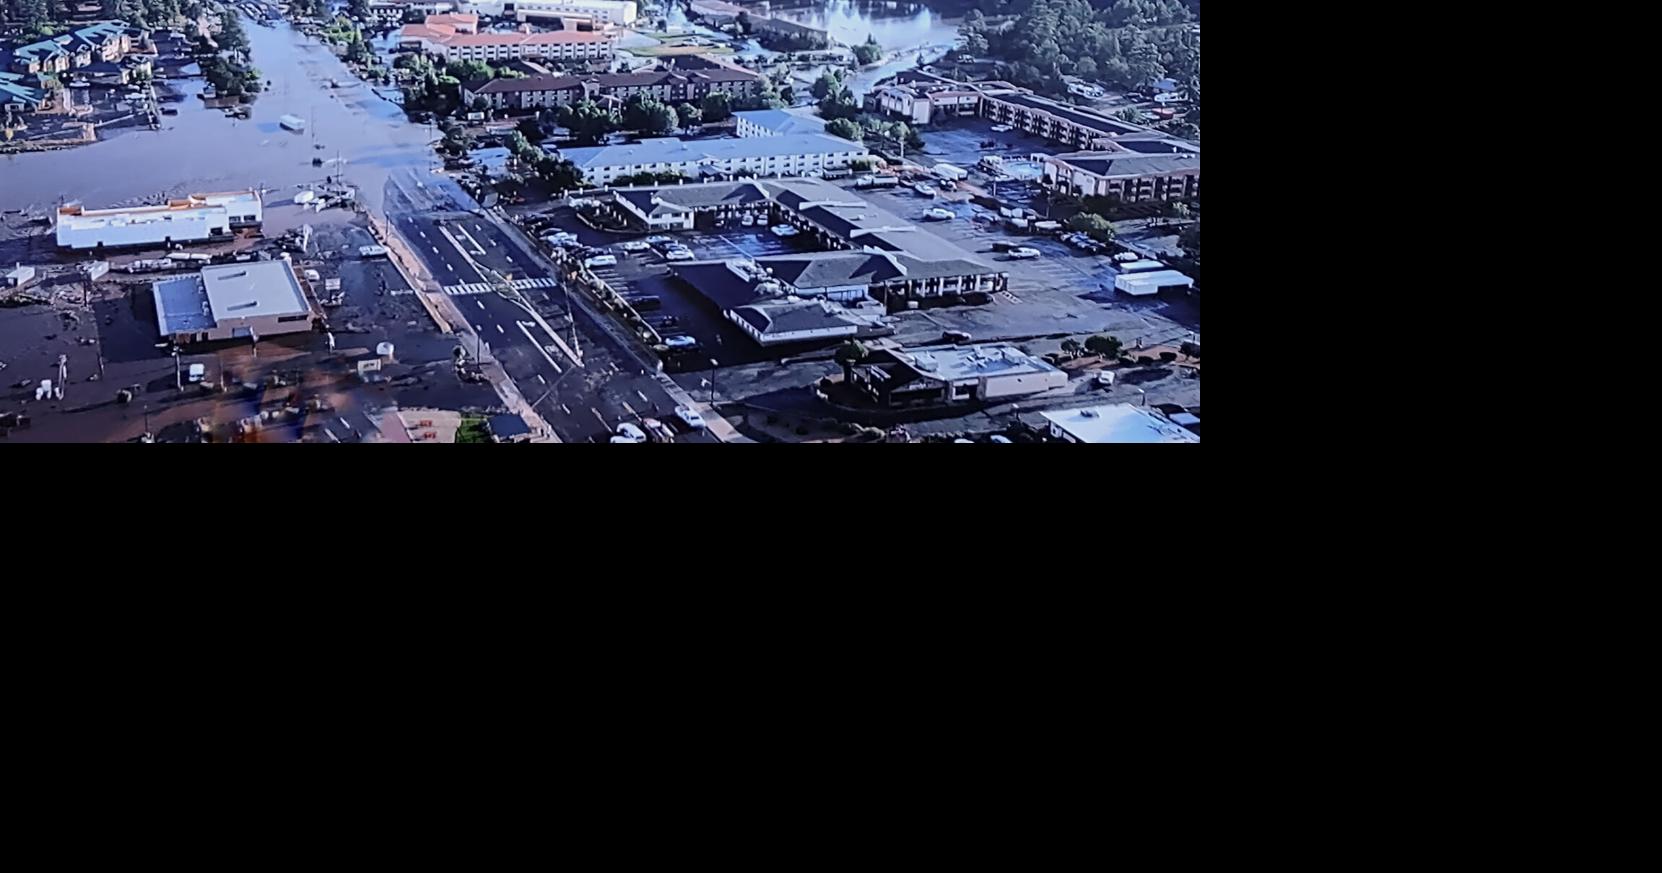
[58,191,264,249]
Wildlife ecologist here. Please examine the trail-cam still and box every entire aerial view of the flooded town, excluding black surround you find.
[0,0,1202,444]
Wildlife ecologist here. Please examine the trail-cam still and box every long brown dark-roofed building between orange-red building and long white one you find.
[462,65,761,109]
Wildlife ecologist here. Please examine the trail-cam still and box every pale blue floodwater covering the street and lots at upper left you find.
[0,17,432,211]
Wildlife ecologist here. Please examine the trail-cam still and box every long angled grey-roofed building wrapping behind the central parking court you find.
[612,177,1009,308]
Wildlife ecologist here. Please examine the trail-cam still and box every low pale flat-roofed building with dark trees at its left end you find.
[849,343,1067,407]
